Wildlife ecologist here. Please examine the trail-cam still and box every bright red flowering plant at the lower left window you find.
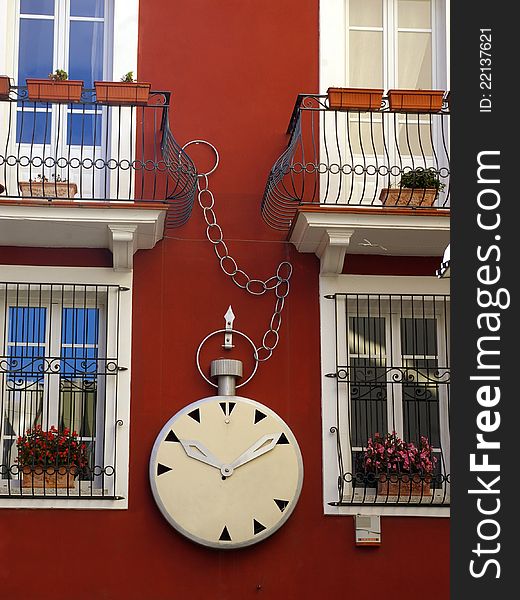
[16,425,88,469]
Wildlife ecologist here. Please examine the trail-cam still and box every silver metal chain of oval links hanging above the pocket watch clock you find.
[197,173,292,362]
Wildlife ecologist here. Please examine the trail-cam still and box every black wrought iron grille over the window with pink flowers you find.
[327,294,450,506]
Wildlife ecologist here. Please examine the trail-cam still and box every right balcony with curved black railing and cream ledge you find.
[261,94,450,272]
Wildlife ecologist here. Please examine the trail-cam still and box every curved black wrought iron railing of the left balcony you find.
[0,87,197,227]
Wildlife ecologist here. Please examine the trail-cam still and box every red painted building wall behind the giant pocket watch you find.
[0,0,449,600]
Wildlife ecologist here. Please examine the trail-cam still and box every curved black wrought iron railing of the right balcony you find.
[261,94,450,230]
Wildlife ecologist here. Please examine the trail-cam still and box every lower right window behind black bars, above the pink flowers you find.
[336,294,449,503]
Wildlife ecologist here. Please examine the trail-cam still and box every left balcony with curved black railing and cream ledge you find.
[0,87,197,268]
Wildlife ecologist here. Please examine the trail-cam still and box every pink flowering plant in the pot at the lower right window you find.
[361,431,437,475]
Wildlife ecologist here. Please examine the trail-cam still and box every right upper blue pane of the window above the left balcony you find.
[69,21,104,88]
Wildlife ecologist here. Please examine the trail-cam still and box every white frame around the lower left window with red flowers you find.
[0,265,133,509]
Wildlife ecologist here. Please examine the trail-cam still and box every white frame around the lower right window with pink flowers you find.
[320,275,450,517]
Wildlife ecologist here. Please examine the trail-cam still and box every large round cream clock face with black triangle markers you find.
[150,396,303,548]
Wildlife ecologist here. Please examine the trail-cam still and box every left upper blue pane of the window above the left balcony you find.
[18,19,54,85]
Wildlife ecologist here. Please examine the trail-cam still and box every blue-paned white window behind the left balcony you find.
[16,0,108,149]
